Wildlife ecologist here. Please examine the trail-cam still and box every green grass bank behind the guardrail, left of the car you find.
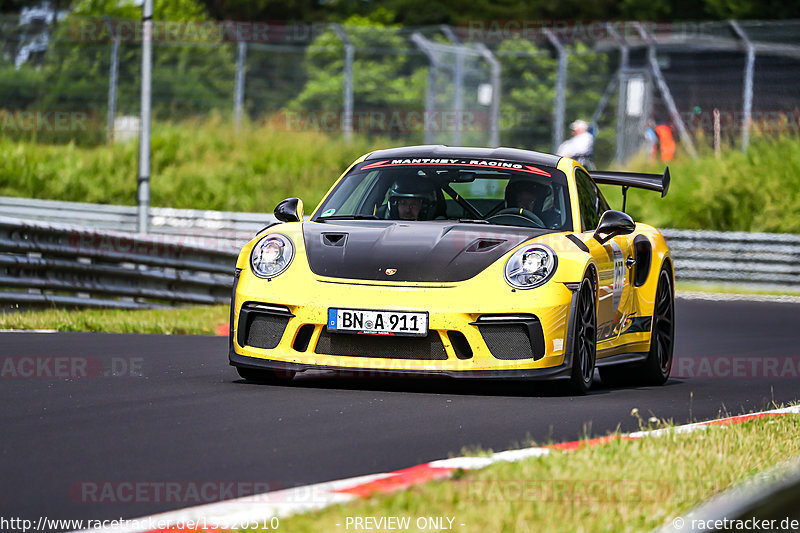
[0,117,386,212]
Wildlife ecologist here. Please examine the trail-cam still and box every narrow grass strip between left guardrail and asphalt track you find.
[0,305,230,335]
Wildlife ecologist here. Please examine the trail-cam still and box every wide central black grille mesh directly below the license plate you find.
[314,330,447,361]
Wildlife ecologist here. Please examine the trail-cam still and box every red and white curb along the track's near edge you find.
[79,405,800,533]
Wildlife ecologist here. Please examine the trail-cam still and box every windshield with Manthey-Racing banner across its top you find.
[313,159,572,231]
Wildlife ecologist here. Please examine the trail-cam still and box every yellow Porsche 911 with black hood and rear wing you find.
[229,146,674,394]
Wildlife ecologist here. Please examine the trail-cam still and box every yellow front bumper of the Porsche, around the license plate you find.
[229,269,574,379]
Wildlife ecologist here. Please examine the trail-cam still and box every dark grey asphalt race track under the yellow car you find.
[0,300,800,520]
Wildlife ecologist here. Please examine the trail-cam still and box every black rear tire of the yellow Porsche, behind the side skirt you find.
[600,265,675,386]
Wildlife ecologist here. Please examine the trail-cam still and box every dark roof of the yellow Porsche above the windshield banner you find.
[365,144,561,167]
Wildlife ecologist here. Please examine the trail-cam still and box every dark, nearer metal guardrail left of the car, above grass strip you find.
[0,216,238,309]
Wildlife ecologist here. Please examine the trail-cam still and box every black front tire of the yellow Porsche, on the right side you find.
[569,278,597,395]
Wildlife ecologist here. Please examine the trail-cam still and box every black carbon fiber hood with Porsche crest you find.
[303,220,553,282]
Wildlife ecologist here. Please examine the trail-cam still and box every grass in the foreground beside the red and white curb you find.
[255,415,800,533]
